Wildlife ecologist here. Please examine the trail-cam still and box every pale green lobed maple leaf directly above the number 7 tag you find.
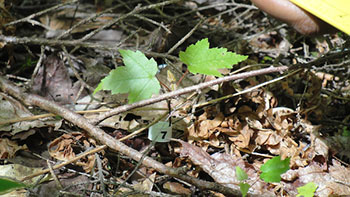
[94,50,160,103]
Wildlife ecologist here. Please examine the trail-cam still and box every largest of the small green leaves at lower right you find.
[260,156,290,183]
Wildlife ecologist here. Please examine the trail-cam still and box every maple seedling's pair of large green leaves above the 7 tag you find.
[94,39,248,103]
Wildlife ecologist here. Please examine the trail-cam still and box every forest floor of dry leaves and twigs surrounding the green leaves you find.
[0,0,350,196]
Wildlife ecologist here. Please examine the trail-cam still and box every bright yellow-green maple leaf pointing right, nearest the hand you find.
[179,38,248,77]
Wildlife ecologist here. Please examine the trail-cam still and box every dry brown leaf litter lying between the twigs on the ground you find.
[0,1,350,196]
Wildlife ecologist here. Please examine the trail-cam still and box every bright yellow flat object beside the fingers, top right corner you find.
[290,0,350,35]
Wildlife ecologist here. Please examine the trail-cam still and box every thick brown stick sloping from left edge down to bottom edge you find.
[0,76,240,196]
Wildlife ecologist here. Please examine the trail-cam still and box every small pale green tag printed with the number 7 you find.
[148,121,172,142]
